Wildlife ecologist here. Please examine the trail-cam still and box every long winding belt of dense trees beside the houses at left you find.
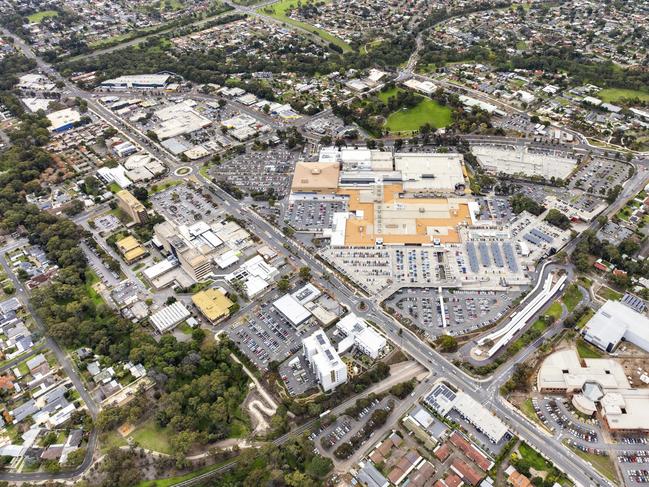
[0,73,247,460]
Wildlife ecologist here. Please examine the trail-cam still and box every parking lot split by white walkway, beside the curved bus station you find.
[386,288,518,336]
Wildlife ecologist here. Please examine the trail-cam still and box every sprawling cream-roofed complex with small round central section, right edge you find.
[537,349,649,433]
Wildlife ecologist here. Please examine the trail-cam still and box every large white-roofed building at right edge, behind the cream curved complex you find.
[582,301,649,353]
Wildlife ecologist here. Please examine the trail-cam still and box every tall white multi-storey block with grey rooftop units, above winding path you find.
[302,330,347,392]
